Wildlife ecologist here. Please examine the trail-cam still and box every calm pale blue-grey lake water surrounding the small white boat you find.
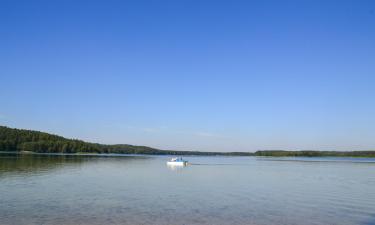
[0,154,375,225]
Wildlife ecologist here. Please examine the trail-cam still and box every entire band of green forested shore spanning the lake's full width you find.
[0,126,375,157]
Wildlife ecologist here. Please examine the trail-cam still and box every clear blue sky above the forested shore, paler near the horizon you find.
[0,0,375,151]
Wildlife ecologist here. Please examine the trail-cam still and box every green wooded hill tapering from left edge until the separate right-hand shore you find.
[0,126,253,155]
